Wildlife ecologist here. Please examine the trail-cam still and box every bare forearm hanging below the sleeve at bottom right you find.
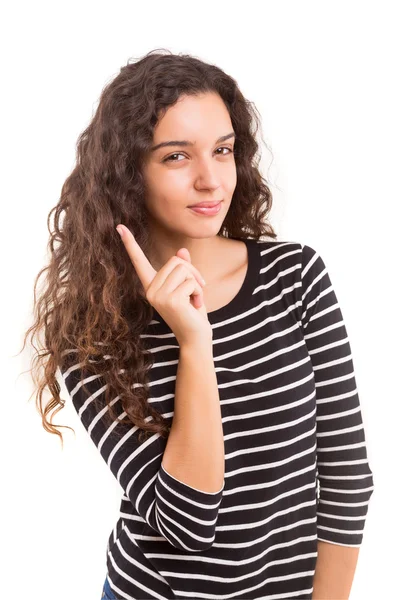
[312,540,360,600]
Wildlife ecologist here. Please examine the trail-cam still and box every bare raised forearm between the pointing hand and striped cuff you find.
[162,340,225,493]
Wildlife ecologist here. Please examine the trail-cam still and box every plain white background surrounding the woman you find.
[0,0,400,600]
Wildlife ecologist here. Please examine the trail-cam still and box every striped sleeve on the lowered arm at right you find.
[301,245,374,546]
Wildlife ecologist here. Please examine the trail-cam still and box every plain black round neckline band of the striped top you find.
[153,237,261,326]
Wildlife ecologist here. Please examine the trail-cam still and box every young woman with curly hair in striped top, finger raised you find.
[22,52,374,599]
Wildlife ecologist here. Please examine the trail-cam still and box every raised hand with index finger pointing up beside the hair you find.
[117,225,212,346]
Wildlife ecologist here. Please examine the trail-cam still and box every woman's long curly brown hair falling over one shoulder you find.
[18,49,277,445]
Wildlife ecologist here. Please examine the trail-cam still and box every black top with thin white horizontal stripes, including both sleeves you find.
[63,239,374,600]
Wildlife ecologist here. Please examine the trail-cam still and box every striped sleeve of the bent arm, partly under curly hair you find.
[61,351,225,552]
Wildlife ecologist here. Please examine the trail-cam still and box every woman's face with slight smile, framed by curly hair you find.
[144,93,237,240]
